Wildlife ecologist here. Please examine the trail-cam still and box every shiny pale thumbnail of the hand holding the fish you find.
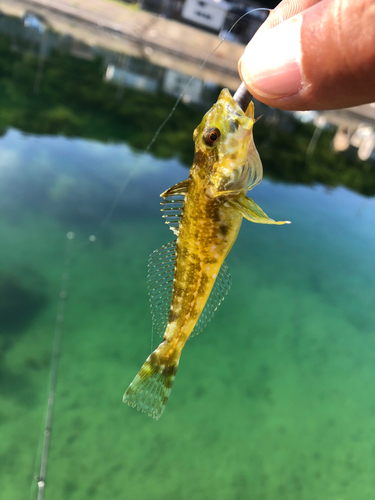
[239,16,302,98]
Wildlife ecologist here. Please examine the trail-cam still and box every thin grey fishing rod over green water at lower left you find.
[29,231,75,500]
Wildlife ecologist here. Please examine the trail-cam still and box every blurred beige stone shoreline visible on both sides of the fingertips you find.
[0,0,375,160]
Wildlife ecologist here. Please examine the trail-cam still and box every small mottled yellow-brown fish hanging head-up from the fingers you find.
[123,89,289,420]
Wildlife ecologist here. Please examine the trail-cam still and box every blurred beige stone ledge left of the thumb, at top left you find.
[0,0,244,89]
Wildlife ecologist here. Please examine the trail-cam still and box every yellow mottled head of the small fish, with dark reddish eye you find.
[193,89,263,197]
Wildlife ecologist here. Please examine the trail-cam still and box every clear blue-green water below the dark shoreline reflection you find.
[0,12,375,500]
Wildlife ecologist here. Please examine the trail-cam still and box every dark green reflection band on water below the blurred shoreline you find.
[0,10,375,195]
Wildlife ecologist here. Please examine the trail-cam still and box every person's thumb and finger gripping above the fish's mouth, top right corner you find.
[238,0,375,110]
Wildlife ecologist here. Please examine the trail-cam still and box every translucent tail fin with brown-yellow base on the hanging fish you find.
[122,352,178,420]
